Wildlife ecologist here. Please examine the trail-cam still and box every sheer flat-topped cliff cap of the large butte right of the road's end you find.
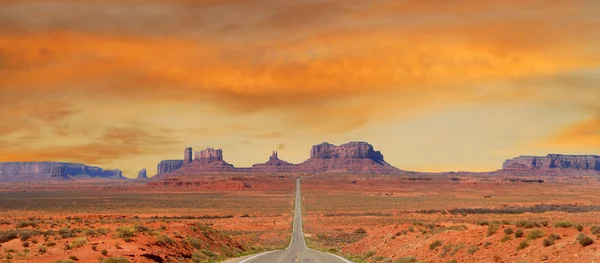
[310,142,383,162]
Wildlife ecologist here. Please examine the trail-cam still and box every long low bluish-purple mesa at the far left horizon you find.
[0,162,124,182]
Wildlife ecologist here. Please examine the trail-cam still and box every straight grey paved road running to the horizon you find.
[230,179,352,263]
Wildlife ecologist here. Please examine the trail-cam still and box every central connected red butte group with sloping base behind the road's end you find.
[152,142,401,175]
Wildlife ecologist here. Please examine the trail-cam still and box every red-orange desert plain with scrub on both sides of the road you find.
[0,173,600,263]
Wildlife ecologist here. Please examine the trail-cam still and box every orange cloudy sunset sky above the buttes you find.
[0,0,600,177]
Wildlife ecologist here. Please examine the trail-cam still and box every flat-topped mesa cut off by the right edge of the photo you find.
[502,154,600,171]
